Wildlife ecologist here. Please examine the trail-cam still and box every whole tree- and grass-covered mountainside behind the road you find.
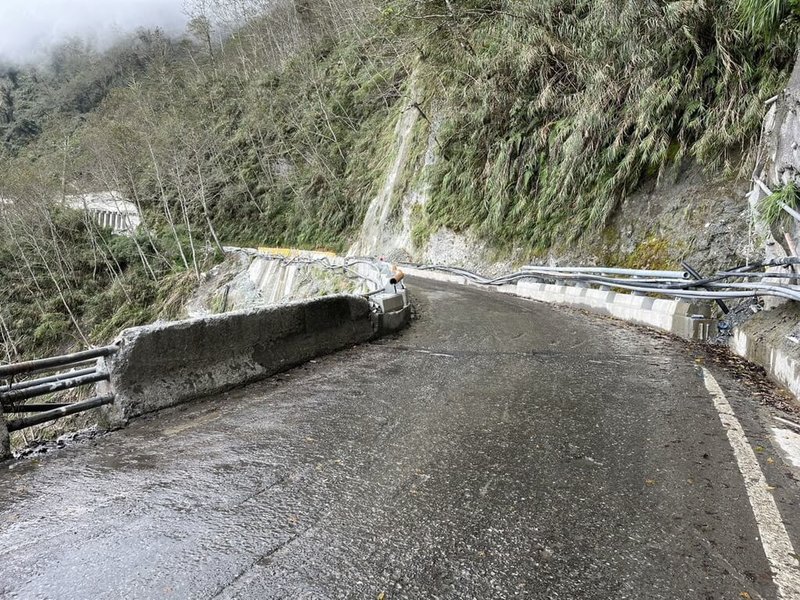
[0,0,800,361]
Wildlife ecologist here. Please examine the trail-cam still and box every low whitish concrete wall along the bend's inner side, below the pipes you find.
[403,268,716,340]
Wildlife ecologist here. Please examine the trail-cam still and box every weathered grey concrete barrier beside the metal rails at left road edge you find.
[98,295,380,428]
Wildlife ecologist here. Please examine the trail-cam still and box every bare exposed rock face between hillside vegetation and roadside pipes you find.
[349,76,764,273]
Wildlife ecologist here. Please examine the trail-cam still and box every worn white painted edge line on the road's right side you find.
[702,367,800,600]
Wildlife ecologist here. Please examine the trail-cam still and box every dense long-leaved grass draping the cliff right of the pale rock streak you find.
[416,0,796,251]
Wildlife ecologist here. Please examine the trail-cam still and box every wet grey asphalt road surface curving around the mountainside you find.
[0,281,800,600]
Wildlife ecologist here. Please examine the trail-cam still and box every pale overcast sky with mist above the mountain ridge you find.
[0,0,186,61]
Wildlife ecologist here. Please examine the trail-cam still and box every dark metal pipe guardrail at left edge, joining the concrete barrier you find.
[0,346,118,432]
